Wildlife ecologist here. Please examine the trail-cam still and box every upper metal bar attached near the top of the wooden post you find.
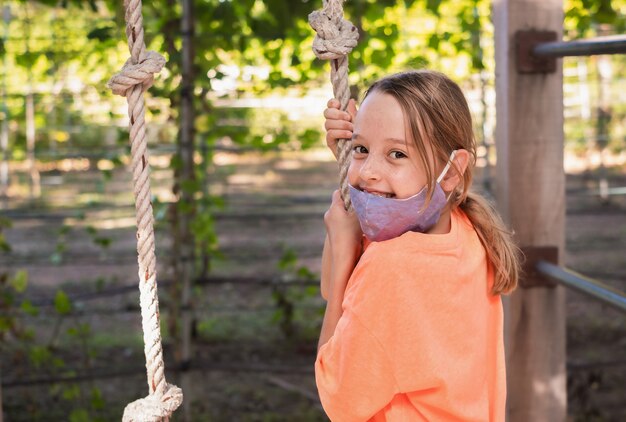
[532,35,626,57]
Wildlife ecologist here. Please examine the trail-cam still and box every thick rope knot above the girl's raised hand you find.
[309,0,359,60]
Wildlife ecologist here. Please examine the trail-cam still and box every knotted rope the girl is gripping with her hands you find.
[309,0,359,209]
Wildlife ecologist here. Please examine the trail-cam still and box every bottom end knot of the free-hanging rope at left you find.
[122,384,183,422]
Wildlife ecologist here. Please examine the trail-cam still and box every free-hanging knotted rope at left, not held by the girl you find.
[107,0,183,422]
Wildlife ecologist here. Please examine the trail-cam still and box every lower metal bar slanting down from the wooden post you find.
[535,261,626,312]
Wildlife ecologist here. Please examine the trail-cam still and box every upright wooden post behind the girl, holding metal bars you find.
[493,0,567,422]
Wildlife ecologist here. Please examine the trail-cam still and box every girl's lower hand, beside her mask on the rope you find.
[324,190,363,262]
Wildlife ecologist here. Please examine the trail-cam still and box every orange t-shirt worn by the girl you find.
[315,211,506,422]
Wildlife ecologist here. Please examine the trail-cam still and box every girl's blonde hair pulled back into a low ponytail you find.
[365,70,520,295]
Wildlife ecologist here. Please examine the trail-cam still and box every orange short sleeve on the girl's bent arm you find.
[315,311,398,422]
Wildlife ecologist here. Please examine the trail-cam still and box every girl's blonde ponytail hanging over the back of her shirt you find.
[459,192,521,295]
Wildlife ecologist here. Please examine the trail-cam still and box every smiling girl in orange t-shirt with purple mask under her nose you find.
[315,71,519,422]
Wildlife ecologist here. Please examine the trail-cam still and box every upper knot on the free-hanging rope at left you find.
[107,51,165,97]
